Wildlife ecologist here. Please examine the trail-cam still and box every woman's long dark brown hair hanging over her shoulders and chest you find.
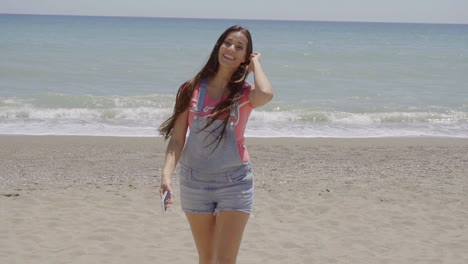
[159,25,253,144]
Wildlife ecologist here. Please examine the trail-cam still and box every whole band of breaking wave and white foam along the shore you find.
[0,107,468,137]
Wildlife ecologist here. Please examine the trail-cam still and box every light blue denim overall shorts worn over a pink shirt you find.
[180,80,254,215]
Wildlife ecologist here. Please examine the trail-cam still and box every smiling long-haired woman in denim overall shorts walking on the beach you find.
[159,26,273,263]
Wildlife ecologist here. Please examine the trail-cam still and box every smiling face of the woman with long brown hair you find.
[218,32,248,69]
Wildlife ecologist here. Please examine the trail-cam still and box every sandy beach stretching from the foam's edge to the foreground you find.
[0,136,468,264]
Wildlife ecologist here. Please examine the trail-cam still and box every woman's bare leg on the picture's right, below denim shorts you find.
[214,211,249,264]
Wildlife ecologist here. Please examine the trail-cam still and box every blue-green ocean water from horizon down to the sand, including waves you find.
[0,15,468,138]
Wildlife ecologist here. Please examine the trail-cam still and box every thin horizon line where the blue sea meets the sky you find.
[0,12,468,25]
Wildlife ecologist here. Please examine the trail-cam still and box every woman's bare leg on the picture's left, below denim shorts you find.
[185,212,216,264]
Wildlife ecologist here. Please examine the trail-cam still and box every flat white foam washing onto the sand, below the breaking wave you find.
[0,119,468,138]
